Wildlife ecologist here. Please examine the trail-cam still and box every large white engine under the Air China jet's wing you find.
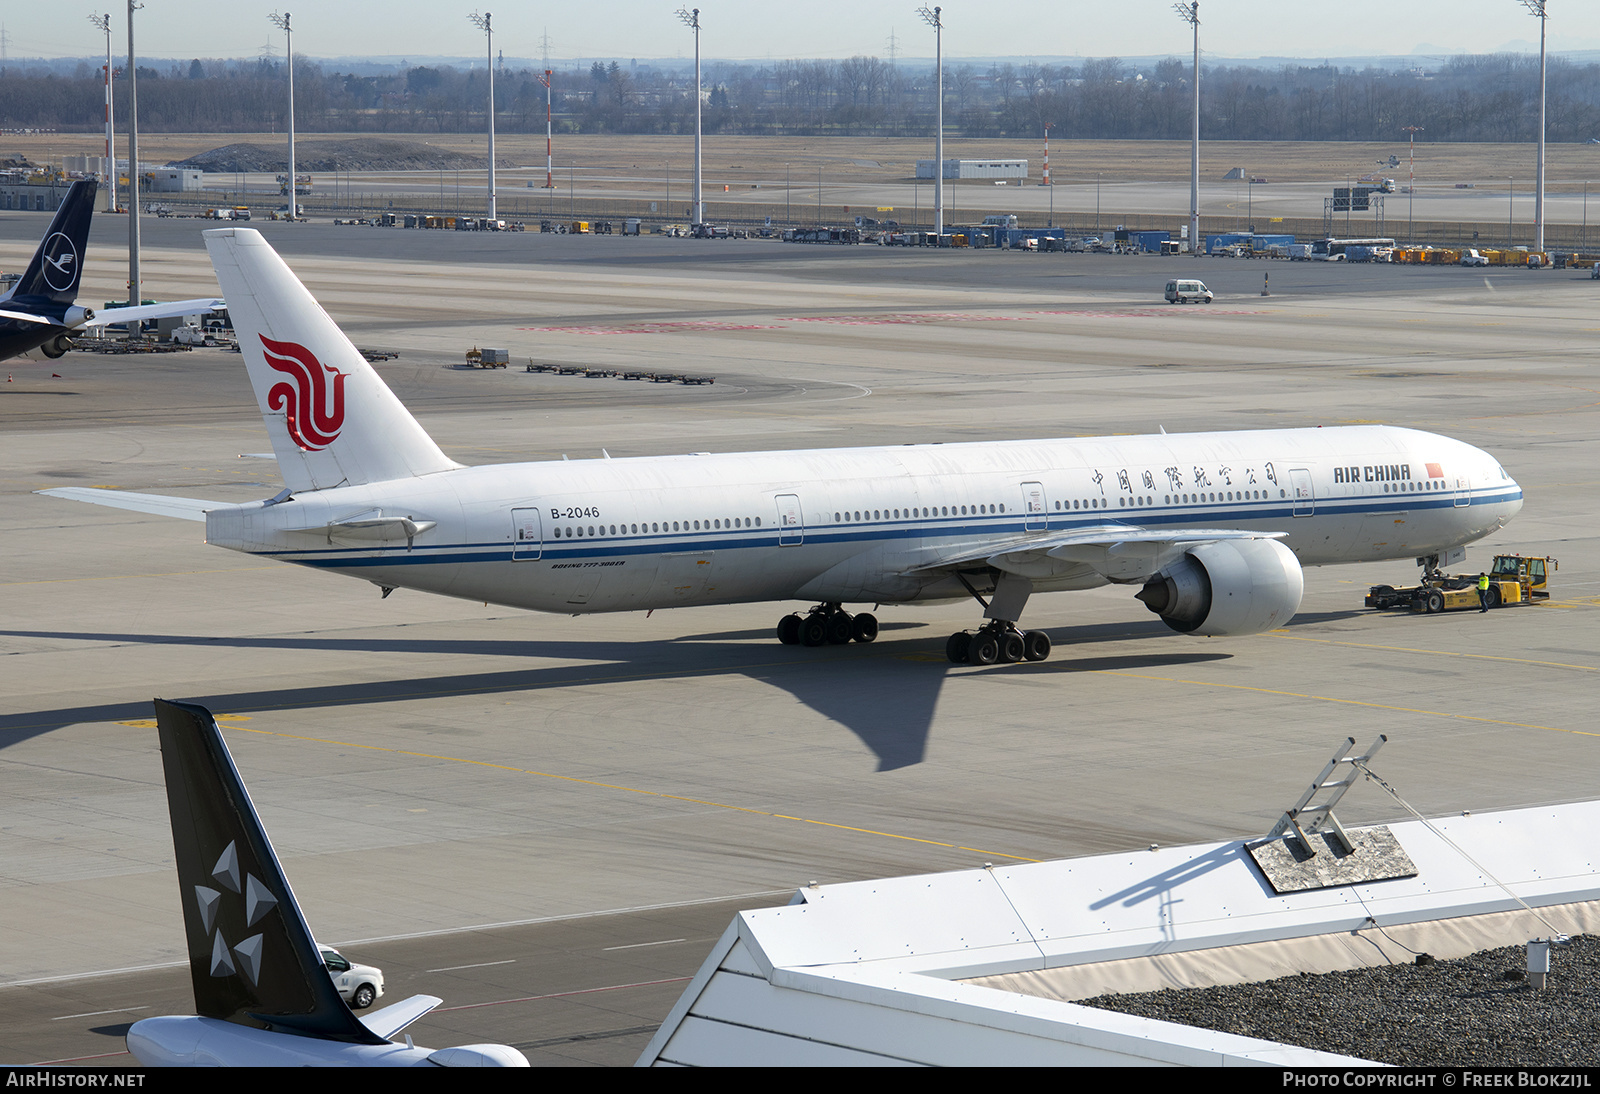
[1136,539,1306,638]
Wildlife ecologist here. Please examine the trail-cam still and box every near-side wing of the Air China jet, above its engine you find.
[907,525,1286,581]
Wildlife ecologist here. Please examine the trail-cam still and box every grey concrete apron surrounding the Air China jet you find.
[0,216,1600,1064]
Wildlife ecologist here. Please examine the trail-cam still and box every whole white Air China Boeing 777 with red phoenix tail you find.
[42,229,1522,664]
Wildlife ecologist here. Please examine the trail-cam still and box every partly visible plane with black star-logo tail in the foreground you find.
[128,699,528,1067]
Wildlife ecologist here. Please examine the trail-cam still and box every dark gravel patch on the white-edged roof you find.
[1080,936,1600,1067]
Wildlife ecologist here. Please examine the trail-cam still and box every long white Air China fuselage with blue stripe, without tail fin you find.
[206,425,1522,613]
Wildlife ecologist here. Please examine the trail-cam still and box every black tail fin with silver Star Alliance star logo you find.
[155,699,384,1044]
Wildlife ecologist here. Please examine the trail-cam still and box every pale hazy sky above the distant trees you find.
[9,0,1600,61]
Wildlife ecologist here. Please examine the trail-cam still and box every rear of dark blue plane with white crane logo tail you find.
[0,179,222,361]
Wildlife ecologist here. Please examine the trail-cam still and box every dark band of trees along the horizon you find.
[0,54,1600,142]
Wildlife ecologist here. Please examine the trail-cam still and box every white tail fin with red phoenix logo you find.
[205,229,461,491]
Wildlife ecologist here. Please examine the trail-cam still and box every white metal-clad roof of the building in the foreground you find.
[638,801,1600,1067]
